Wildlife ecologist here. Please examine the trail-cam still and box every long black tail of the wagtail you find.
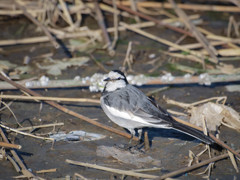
[173,123,215,145]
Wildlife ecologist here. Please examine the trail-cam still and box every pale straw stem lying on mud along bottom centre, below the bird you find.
[65,159,158,179]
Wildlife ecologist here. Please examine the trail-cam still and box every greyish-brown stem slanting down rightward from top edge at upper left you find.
[14,0,60,49]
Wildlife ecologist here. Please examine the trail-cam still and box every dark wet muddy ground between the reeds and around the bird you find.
[0,9,240,179]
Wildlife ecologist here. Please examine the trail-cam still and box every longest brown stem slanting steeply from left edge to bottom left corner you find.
[0,127,35,179]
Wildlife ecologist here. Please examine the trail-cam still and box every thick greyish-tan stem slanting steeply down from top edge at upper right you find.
[169,0,218,63]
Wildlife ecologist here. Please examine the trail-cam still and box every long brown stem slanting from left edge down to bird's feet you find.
[0,74,138,141]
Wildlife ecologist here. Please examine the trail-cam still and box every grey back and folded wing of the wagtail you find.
[104,85,173,126]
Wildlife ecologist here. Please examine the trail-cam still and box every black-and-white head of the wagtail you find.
[104,70,128,92]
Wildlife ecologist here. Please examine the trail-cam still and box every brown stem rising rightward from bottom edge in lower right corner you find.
[157,150,240,180]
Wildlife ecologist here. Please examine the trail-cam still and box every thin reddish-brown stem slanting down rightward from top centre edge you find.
[103,0,192,36]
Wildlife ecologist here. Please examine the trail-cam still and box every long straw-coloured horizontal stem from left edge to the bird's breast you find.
[0,95,100,104]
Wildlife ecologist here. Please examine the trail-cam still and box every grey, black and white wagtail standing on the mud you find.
[100,70,214,144]
